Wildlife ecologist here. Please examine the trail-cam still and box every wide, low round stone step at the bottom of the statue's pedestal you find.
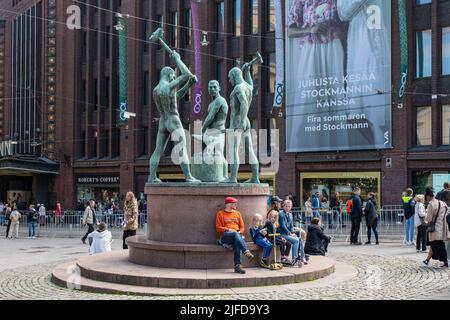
[52,251,335,294]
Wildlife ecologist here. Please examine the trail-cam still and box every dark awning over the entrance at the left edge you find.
[0,157,59,176]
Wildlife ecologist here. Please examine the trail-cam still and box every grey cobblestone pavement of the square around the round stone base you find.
[0,239,450,300]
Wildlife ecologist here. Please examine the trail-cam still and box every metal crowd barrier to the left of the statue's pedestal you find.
[0,211,147,238]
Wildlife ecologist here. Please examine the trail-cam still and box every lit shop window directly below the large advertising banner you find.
[300,172,381,206]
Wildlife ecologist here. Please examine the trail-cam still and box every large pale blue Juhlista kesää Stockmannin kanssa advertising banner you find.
[285,0,392,152]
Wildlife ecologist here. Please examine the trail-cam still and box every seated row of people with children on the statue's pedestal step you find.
[216,196,331,274]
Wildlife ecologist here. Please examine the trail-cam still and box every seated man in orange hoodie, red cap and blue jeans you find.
[216,197,254,274]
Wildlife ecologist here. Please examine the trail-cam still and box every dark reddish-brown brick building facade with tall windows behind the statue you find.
[0,0,450,208]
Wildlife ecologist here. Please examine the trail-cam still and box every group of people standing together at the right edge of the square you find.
[402,182,450,268]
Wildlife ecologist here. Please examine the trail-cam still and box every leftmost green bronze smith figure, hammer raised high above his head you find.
[148,28,201,183]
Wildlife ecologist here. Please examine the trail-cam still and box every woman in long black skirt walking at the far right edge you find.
[424,187,448,268]
